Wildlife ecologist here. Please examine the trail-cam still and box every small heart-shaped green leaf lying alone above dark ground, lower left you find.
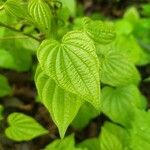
[5,113,48,141]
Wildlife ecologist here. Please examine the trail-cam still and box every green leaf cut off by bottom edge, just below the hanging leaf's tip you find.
[44,135,79,150]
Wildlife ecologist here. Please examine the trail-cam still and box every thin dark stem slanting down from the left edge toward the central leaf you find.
[0,22,41,42]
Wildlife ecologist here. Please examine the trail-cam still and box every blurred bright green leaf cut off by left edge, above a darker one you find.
[0,49,15,69]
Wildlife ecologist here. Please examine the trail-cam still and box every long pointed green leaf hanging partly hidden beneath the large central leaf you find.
[35,67,82,138]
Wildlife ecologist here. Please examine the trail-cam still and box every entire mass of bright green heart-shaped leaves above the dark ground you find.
[0,0,150,150]
